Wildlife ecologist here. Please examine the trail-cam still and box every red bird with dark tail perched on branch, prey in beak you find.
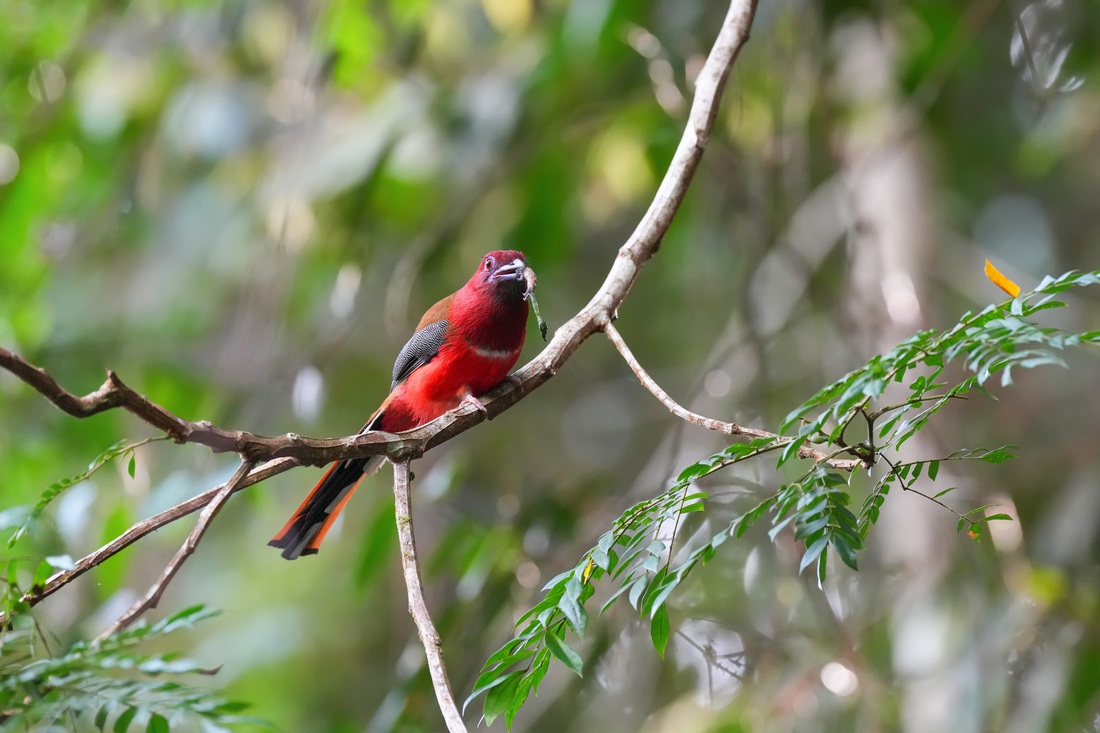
[267,250,536,560]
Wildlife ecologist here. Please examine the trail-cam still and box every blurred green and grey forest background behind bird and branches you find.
[0,0,1100,733]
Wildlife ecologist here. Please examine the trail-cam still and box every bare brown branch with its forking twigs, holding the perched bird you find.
[0,0,787,731]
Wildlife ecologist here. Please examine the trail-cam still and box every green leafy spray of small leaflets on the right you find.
[466,271,1100,726]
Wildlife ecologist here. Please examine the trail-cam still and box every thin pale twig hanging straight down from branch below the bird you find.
[394,458,466,733]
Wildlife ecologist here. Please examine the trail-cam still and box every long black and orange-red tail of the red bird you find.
[267,408,386,560]
